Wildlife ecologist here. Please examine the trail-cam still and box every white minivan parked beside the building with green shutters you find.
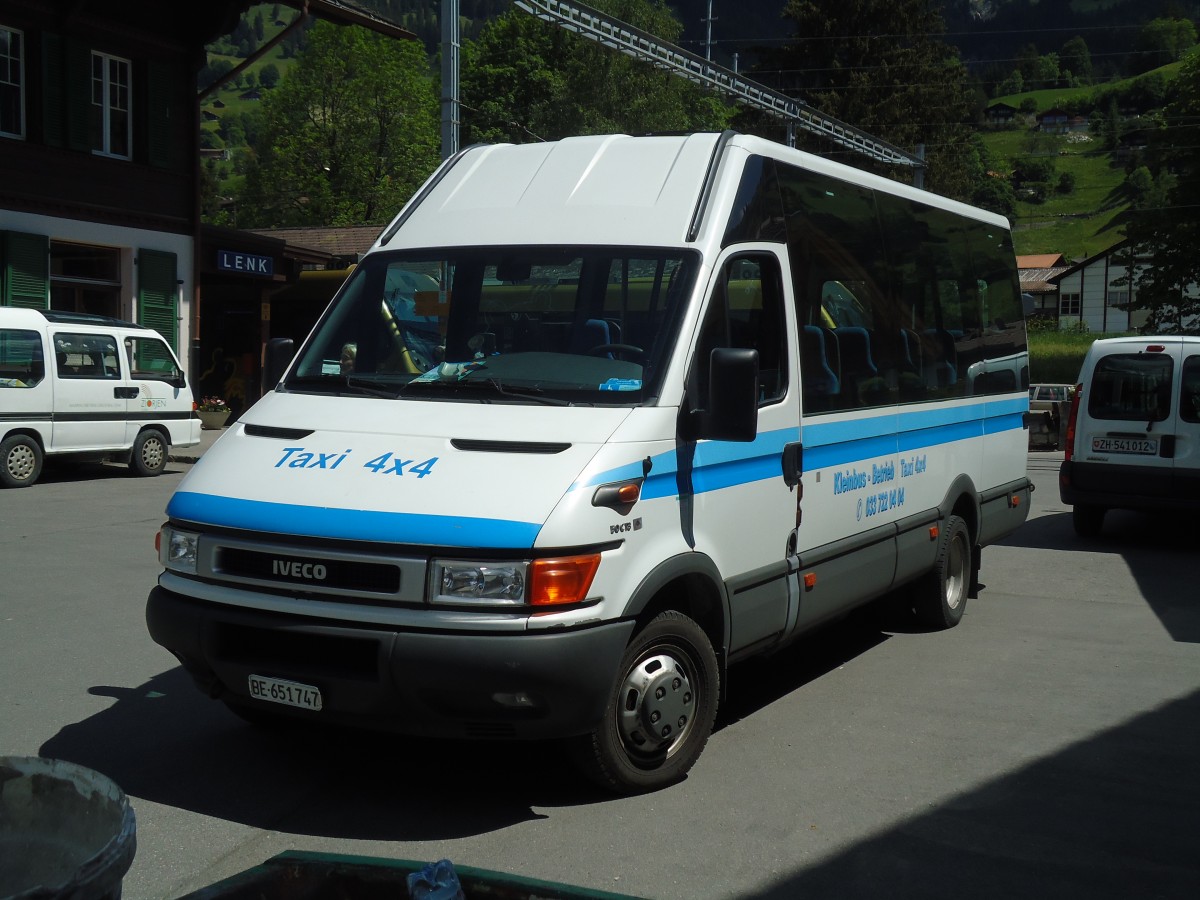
[0,307,200,487]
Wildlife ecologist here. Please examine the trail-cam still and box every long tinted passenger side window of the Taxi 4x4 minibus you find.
[768,163,1030,412]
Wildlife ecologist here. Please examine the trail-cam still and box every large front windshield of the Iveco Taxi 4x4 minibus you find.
[286,247,697,406]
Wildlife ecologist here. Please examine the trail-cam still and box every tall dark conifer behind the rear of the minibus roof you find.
[756,0,980,199]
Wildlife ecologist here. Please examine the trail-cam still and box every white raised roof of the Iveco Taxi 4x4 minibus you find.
[376,132,1008,250]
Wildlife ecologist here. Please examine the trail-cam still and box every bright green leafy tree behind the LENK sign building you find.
[231,22,438,228]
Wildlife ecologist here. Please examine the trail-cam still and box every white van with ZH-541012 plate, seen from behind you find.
[1058,335,1200,536]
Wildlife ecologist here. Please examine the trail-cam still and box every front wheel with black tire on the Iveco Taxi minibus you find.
[575,611,721,794]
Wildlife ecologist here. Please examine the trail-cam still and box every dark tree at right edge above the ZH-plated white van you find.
[1126,55,1200,330]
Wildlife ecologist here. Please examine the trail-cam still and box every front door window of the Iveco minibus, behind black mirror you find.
[692,253,787,407]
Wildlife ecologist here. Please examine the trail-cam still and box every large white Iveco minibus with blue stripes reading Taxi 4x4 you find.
[146,132,1030,792]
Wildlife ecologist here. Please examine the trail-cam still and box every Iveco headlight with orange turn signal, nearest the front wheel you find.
[430,553,600,607]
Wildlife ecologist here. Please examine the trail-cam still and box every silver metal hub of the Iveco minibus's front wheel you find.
[620,655,696,752]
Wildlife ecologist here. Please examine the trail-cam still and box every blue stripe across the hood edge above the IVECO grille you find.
[167,491,541,548]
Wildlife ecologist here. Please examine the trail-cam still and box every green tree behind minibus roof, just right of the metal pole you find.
[462,0,730,143]
